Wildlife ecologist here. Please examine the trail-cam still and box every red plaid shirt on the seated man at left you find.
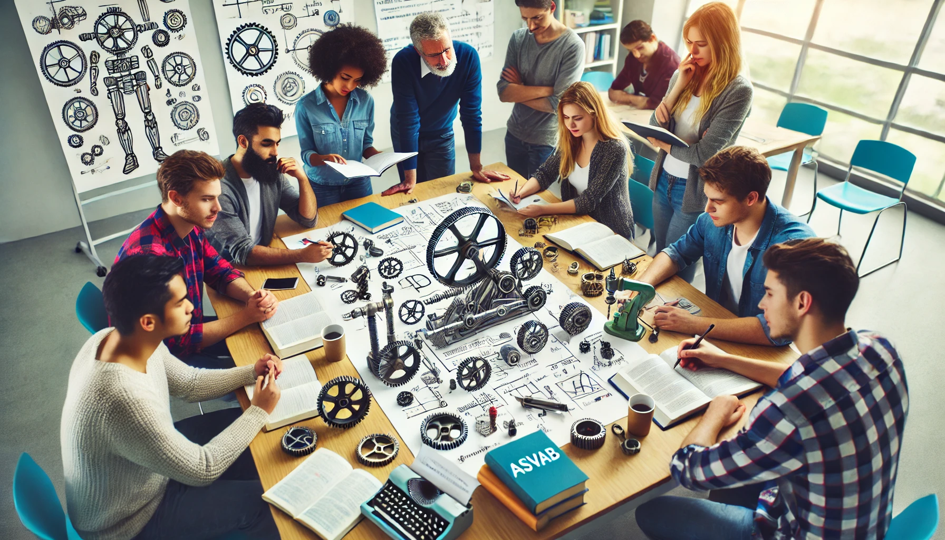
[115,206,243,357]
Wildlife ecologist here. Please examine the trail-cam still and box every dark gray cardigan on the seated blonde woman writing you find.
[535,139,634,239]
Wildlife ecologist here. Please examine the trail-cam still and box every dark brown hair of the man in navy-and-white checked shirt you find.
[763,238,860,322]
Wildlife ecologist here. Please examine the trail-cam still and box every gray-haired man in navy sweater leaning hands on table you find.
[383,12,488,195]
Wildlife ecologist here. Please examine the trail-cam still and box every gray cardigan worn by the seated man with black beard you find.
[207,156,318,265]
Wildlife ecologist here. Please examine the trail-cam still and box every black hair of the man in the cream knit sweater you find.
[102,255,184,336]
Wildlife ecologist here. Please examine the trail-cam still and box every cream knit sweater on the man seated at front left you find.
[60,328,268,540]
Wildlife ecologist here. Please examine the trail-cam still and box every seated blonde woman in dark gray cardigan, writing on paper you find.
[512,82,633,239]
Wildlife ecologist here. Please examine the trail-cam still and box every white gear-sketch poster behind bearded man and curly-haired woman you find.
[213,0,354,137]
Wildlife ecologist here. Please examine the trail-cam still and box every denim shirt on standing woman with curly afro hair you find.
[295,84,374,186]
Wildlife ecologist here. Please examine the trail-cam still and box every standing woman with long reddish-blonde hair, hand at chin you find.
[650,2,752,280]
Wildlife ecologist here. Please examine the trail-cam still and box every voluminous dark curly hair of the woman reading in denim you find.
[308,24,387,87]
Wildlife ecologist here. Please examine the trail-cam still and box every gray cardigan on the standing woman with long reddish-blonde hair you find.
[650,71,753,213]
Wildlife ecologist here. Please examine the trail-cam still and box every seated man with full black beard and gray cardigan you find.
[207,103,331,266]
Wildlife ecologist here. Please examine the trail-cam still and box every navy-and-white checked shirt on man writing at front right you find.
[670,330,909,540]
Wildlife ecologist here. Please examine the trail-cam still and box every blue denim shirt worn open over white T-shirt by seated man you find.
[663,198,815,345]
